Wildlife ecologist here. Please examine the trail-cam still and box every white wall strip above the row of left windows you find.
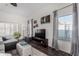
[0,11,25,23]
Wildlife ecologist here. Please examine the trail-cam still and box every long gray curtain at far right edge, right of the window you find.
[71,4,79,56]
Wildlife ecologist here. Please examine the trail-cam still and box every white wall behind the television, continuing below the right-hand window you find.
[33,5,71,53]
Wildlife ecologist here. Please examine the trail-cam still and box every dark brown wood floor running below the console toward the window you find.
[30,40,71,56]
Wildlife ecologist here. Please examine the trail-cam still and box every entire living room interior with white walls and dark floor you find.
[0,3,79,56]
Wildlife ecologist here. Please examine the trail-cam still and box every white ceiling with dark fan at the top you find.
[0,3,71,16]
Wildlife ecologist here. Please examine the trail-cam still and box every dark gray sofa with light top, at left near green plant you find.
[2,36,17,51]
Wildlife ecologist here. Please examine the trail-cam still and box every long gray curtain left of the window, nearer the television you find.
[52,11,58,49]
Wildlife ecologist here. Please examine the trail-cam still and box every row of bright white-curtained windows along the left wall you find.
[0,23,25,36]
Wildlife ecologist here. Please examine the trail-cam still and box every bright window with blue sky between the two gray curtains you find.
[58,15,72,40]
